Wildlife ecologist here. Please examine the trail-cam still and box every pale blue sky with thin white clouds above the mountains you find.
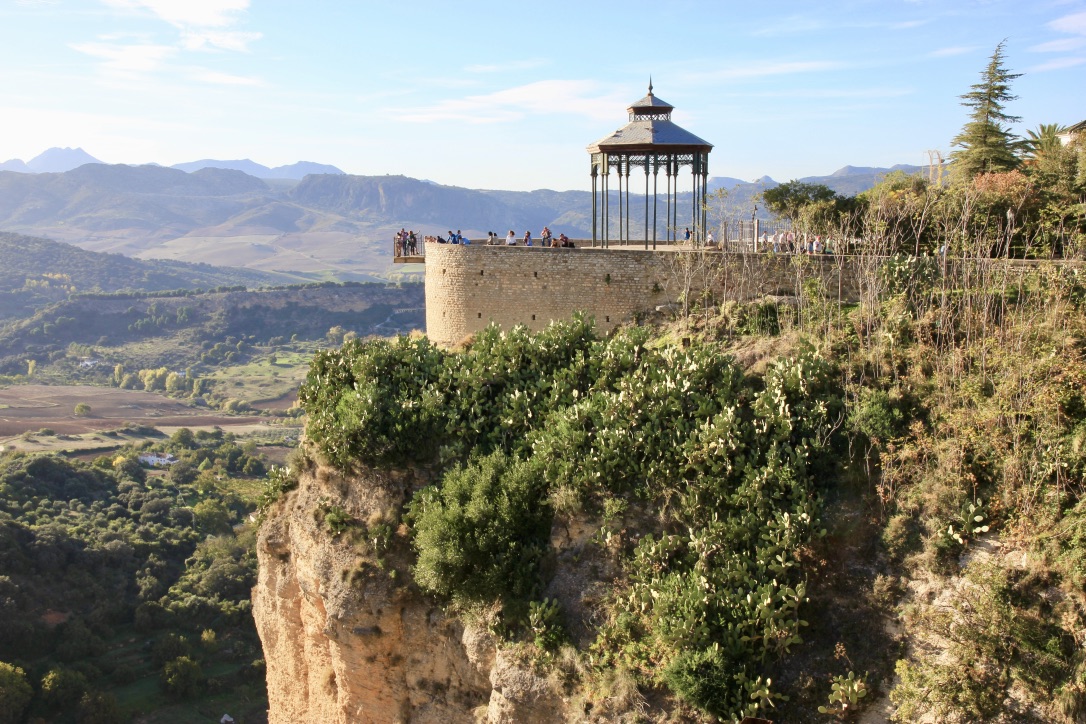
[0,0,1086,190]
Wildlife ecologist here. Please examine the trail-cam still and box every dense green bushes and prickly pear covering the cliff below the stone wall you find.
[300,318,839,717]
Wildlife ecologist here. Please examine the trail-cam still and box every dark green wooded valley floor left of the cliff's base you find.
[0,429,270,722]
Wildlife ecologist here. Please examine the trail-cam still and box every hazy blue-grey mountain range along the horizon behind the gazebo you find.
[0,158,921,281]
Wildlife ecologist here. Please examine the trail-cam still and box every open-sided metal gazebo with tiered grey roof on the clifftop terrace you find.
[588,80,712,249]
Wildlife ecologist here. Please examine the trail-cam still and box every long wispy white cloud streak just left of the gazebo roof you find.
[386,80,624,124]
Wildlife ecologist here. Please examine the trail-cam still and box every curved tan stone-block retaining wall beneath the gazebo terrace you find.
[426,244,858,346]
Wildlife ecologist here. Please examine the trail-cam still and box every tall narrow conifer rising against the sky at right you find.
[950,40,1022,179]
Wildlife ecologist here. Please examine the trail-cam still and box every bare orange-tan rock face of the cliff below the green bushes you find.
[253,468,566,724]
